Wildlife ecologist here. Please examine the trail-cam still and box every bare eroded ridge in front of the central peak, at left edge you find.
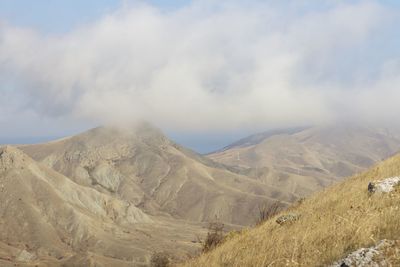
[0,146,203,266]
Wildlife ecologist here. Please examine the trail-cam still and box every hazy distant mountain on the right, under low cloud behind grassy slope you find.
[207,125,400,196]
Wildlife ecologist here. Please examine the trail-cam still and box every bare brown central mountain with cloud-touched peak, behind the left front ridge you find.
[20,124,296,225]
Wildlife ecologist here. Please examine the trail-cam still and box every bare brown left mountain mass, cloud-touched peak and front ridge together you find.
[0,124,302,266]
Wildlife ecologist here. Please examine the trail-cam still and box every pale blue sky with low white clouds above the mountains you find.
[0,0,400,152]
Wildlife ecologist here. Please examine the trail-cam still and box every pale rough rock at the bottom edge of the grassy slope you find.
[330,239,393,267]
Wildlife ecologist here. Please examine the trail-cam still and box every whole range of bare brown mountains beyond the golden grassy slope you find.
[5,123,400,266]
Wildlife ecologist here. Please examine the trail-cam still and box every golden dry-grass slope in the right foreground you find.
[184,155,400,266]
